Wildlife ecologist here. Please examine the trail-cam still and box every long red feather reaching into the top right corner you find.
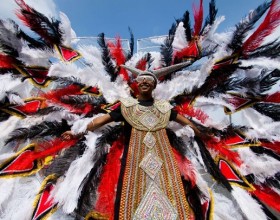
[242,0,280,54]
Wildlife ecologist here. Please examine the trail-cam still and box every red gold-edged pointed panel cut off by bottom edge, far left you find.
[32,183,56,220]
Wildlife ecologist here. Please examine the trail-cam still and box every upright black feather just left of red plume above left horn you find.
[97,33,118,82]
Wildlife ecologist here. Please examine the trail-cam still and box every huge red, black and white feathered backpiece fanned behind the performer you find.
[0,0,280,220]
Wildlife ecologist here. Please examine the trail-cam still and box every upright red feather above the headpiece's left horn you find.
[107,37,129,81]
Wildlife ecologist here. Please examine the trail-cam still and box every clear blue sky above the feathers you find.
[54,0,264,39]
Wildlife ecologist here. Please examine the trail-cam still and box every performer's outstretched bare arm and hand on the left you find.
[61,114,113,140]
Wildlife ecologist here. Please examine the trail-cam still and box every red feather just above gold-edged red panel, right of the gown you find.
[204,137,242,166]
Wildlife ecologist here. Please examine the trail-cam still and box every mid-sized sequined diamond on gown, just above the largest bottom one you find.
[139,152,162,179]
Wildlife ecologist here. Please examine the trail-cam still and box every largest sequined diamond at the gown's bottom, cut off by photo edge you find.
[133,183,178,220]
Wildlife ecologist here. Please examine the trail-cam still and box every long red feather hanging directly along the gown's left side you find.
[95,139,124,219]
